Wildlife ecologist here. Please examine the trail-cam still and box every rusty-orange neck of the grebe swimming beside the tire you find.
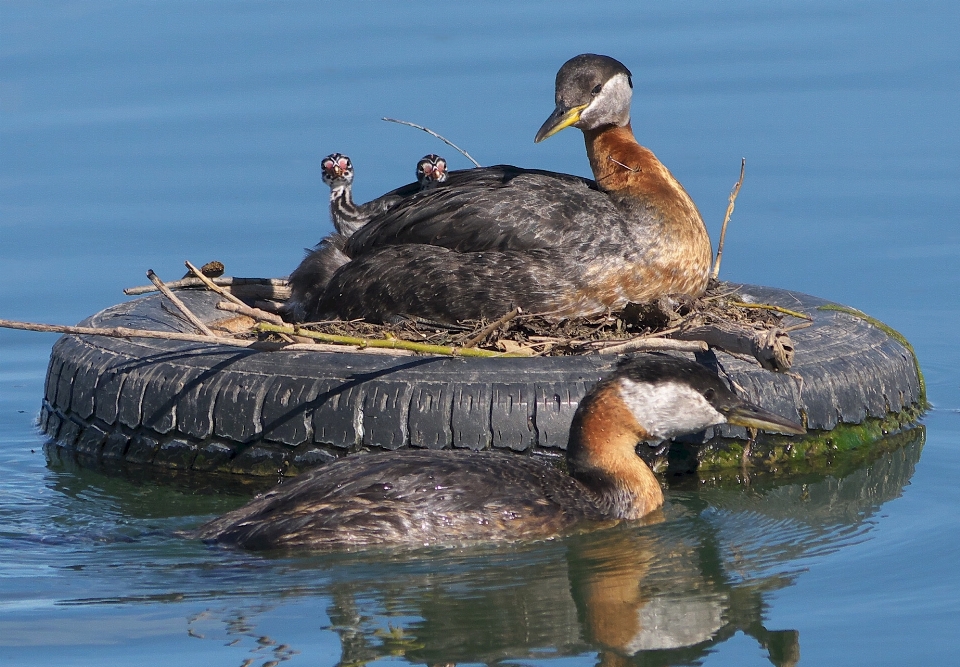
[567,383,663,519]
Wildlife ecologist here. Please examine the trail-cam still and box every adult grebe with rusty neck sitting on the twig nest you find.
[290,54,712,322]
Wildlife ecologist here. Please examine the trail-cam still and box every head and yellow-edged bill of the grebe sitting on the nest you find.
[534,53,633,143]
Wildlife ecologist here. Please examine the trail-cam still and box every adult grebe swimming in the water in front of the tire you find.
[190,354,804,549]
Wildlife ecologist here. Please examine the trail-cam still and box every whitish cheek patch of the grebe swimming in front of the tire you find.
[620,378,727,440]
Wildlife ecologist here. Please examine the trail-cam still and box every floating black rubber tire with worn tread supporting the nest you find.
[40,286,924,475]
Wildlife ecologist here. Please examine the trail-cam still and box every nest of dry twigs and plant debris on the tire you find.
[0,262,812,372]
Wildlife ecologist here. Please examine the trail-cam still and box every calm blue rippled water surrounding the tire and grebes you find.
[0,0,960,667]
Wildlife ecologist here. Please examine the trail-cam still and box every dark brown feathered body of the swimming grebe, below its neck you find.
[198,450,606,549]
